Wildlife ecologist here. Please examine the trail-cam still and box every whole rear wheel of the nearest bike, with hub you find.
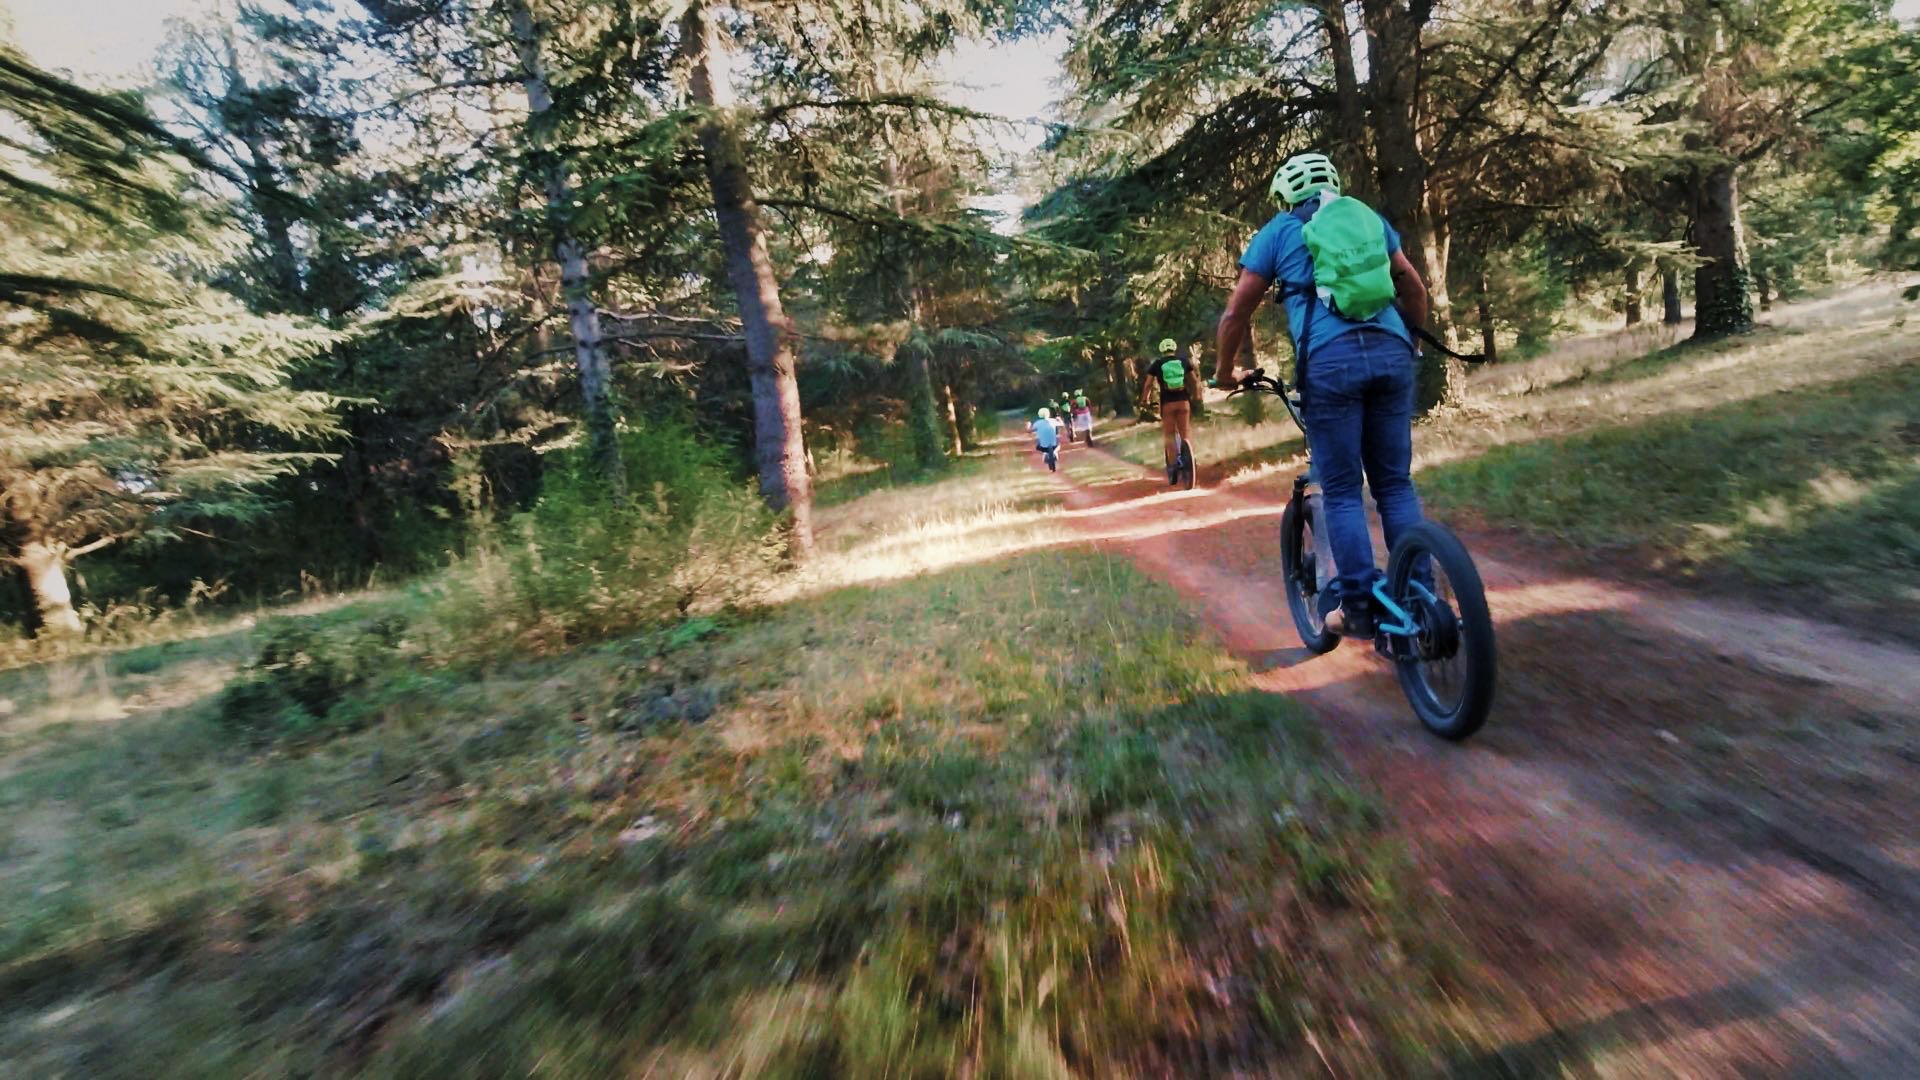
[1386,521,1496,740]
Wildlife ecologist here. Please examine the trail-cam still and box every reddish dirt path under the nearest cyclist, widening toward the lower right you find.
[1029,430,1920,1076]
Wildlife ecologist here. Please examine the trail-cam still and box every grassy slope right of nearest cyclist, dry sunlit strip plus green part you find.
[1421,278,1920,638]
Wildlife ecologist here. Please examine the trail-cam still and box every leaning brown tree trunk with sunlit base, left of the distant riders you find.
[680,4,814,561]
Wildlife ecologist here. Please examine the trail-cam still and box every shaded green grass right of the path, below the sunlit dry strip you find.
[1419,361,1920,636]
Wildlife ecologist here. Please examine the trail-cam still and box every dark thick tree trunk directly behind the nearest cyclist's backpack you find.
[1361,0,1453,411]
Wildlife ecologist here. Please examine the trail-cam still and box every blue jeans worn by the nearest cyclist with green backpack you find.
[1306,329,1421,601]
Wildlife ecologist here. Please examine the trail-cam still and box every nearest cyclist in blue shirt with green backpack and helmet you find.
[1213,154,1427,636]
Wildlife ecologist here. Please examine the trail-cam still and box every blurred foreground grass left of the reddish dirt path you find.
[0,475,1459,1076]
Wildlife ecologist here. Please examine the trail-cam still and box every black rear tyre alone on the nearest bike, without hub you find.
[1386,521,1498,742]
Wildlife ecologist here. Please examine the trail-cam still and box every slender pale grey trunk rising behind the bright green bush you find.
[507,0,626,502]
